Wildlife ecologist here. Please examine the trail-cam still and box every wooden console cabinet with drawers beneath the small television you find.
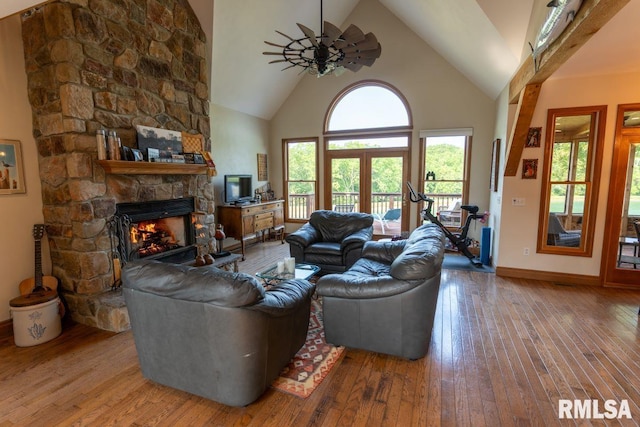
[217,200,284,261]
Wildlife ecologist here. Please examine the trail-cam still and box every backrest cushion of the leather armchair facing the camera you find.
[309,210,373,242]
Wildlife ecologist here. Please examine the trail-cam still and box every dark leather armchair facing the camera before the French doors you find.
[285,210,373,274]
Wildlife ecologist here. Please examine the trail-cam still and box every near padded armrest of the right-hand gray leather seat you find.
[316,274,424,299]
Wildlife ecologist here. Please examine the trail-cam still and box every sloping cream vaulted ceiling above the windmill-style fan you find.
[5,0,640,119]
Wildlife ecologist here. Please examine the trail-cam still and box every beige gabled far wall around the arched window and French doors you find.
[270,1,495,233]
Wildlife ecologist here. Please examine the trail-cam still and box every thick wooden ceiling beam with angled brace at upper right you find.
[504,0,630,176]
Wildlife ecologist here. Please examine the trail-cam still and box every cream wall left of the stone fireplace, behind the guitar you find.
[0,15,51,322]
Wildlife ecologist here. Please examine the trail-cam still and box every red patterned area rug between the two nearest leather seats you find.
[271,300,344,398]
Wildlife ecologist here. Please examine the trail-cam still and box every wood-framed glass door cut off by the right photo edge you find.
[603,104,640,287]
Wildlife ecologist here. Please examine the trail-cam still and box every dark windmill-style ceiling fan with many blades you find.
[263,0,382,77]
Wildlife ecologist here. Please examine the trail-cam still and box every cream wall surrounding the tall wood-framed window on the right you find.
[499,73,640,276]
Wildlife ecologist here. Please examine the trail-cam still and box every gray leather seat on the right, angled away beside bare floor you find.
[316,224,444,359]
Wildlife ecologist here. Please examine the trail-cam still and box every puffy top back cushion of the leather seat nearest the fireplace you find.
[122,260,265,307]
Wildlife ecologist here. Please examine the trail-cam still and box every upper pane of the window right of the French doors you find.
[425,136,466,181]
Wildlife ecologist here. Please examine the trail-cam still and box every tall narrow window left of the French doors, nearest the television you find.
[283,138,318,222]
